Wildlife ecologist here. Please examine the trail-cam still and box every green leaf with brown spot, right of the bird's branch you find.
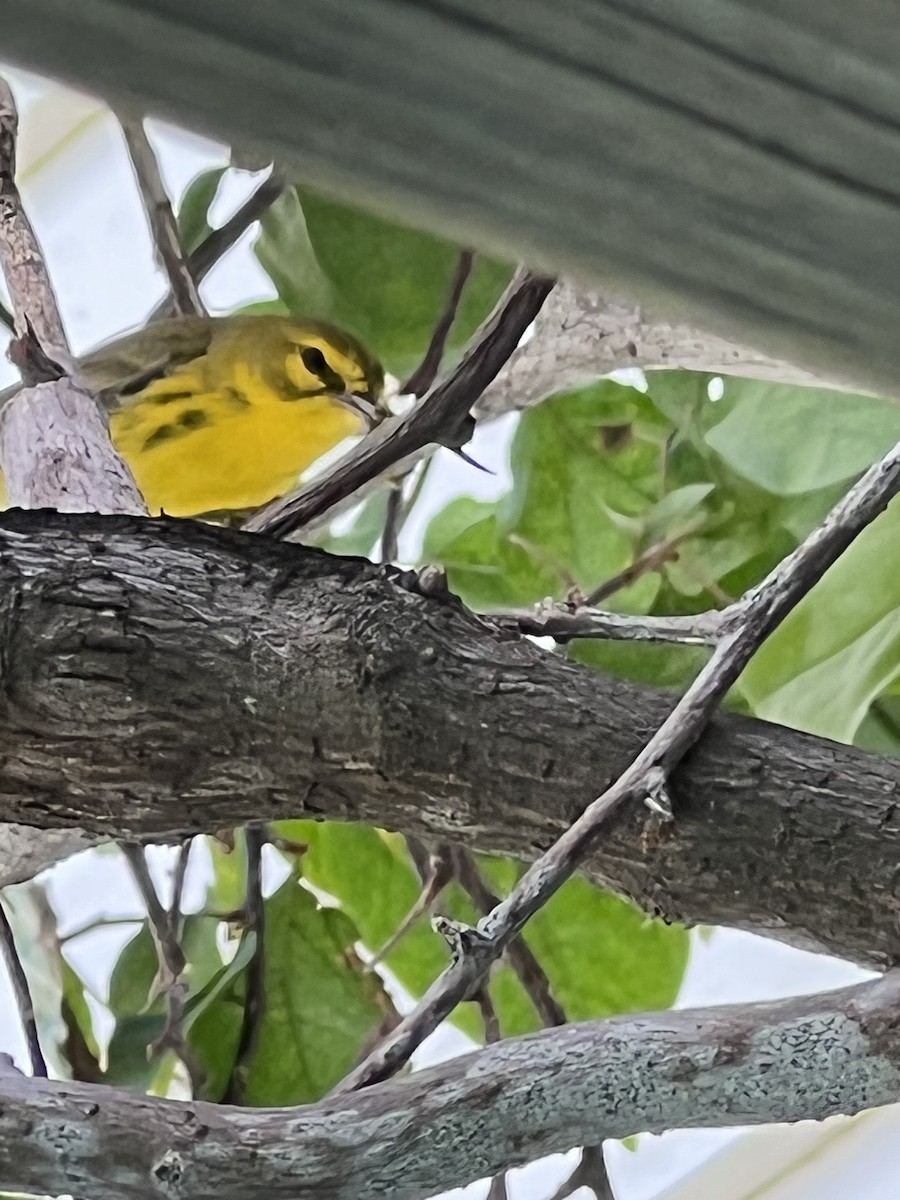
[425,382,676,612]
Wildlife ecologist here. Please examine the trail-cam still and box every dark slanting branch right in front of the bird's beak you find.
[245,271,553,538]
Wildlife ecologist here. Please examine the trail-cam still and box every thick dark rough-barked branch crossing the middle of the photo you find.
[0,512,900,965]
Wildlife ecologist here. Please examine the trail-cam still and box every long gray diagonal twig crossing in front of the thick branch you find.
[336,444,900,1092]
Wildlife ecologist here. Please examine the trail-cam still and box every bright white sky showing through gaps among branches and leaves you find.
[0,63,900,1200]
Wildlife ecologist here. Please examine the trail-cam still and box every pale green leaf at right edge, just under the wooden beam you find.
[706,379,900,496]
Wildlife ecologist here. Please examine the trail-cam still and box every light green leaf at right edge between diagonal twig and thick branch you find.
[739,500,900,742]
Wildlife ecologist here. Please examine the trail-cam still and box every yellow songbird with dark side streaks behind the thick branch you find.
[3,314,385,520]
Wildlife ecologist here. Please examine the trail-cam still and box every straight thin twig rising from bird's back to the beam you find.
[119,113,206,317]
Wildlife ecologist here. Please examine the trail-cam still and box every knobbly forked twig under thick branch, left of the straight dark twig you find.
[119,841,203,1096]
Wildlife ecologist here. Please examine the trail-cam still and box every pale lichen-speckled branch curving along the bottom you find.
[0,972,900,1200]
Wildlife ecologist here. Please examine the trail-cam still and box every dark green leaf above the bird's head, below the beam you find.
[257,188,512,377]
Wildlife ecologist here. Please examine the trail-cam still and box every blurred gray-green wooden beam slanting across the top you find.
[4,0,900,403]
